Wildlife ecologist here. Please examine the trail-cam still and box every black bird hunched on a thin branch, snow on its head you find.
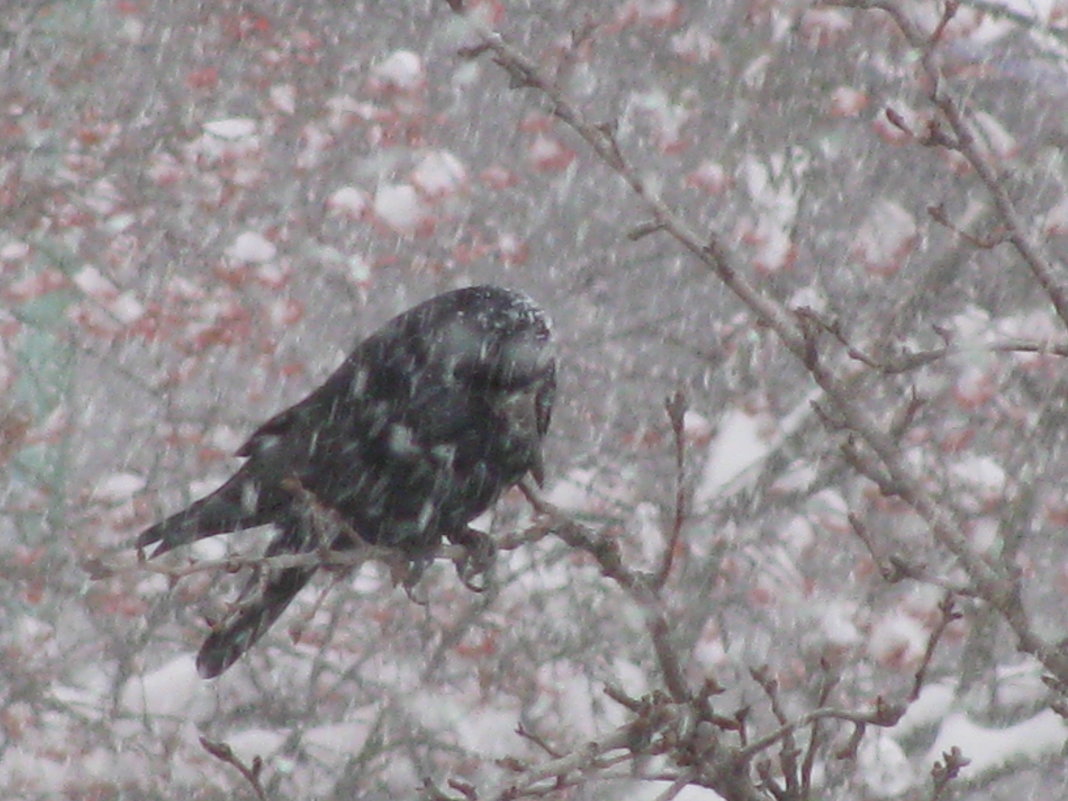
[138,286,555,678]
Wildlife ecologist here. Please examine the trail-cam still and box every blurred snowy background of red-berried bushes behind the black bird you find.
[0,0,1068,801]
